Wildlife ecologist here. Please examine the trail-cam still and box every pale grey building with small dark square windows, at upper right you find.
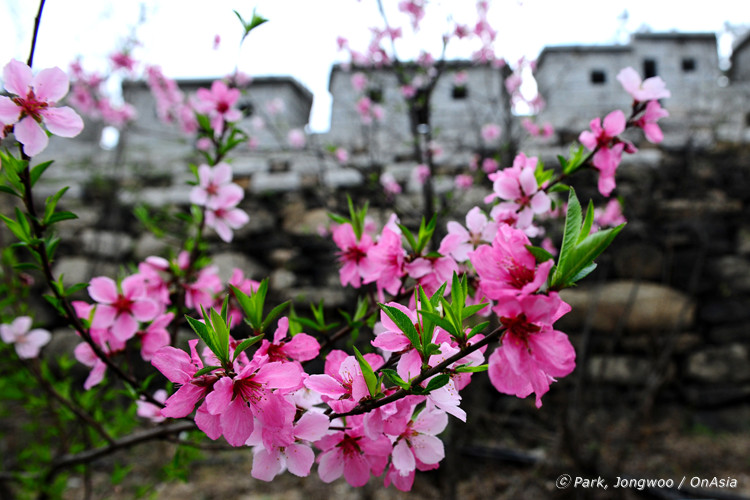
[535,33,722,142]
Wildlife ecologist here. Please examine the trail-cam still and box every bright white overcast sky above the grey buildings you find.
[0,0,750,130]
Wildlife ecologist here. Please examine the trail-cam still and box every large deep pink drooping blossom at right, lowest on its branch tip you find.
[488,294,575,408]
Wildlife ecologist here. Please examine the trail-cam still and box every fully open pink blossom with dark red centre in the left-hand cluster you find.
[88,275,160,342]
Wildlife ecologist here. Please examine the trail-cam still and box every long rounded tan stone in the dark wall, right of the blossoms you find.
[558,281,695,332]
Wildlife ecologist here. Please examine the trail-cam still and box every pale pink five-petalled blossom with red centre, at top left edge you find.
[0,59,83,156]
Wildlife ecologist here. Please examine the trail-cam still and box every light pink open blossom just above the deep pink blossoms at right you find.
[484,153,551,229]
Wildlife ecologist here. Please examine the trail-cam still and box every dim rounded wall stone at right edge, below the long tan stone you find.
[685,343,750,382]
